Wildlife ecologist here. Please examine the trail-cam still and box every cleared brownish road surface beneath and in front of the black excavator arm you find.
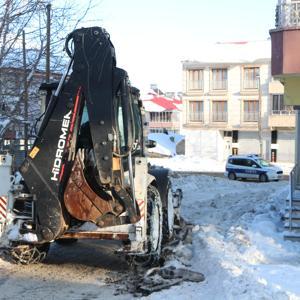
[0,240,132,300]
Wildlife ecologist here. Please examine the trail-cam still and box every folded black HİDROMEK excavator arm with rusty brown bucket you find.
[20,27,144,242]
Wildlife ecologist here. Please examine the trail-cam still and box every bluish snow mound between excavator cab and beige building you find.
[148,133,184,156]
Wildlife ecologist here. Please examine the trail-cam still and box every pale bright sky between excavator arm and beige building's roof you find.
[82,0,277,92]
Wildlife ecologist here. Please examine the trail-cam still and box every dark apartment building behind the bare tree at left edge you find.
[0,67,61,167]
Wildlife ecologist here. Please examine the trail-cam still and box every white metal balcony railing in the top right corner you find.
[276,0,300,28]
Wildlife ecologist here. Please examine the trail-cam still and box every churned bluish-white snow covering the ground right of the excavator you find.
[148,175,300,299]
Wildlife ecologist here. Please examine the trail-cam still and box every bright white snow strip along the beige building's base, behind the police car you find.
[150,155,294,175]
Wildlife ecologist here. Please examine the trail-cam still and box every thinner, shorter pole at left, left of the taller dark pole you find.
[22,30,28,156]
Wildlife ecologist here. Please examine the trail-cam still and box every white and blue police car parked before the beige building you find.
[224,154,283,182]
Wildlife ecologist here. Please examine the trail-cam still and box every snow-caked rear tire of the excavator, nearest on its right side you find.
[132,185,163,267]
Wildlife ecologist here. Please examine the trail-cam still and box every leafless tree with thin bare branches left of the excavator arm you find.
[0,0,94,149]
